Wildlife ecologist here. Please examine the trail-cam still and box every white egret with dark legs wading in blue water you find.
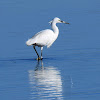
[26,17,69,60]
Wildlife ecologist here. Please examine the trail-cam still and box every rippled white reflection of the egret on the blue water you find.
[28,61,63,100]
